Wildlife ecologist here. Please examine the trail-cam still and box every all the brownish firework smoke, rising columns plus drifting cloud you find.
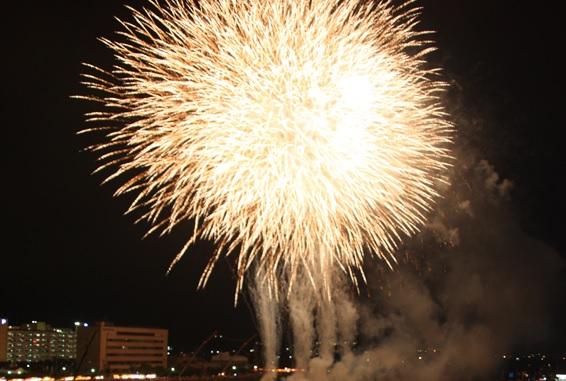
[258,150,565,381]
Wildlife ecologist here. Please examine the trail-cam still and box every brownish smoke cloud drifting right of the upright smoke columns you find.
[358,152,565,380]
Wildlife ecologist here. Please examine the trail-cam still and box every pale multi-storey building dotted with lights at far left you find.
[0,319,77,363]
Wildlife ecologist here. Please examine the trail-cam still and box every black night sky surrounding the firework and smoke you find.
[0,0,566,354]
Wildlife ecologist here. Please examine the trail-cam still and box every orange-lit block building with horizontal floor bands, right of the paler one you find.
[77,322,168,373]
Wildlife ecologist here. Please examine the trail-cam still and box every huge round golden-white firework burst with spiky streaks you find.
[83,0,452,295]
